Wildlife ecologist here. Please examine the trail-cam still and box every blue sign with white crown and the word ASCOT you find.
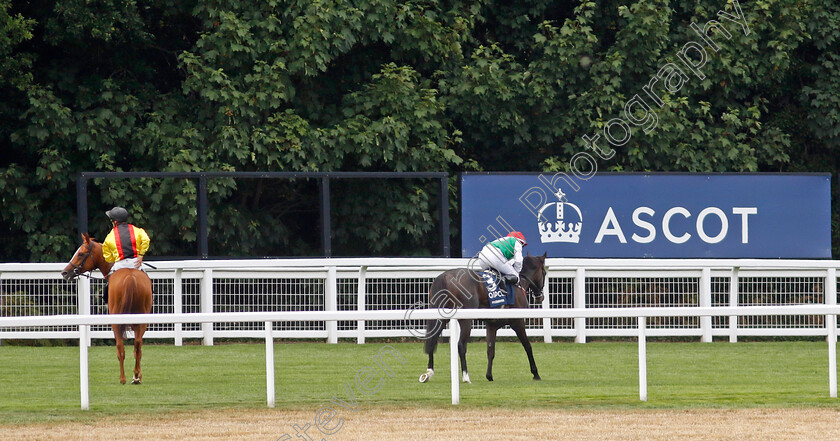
[461,173,831,258]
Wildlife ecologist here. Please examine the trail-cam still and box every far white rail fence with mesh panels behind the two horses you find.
[0,258,838,345]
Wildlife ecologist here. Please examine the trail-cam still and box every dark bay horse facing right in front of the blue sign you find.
[420,254,546,383]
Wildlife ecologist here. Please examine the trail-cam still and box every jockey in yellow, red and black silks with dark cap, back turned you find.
[102,207,150,303]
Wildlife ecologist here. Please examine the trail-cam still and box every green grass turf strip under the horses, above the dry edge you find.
[0,341,840,424]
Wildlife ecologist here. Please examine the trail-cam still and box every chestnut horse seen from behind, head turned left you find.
[61,233,152,384]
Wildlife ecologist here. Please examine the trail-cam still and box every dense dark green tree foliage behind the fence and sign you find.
[0,0,840,261]
